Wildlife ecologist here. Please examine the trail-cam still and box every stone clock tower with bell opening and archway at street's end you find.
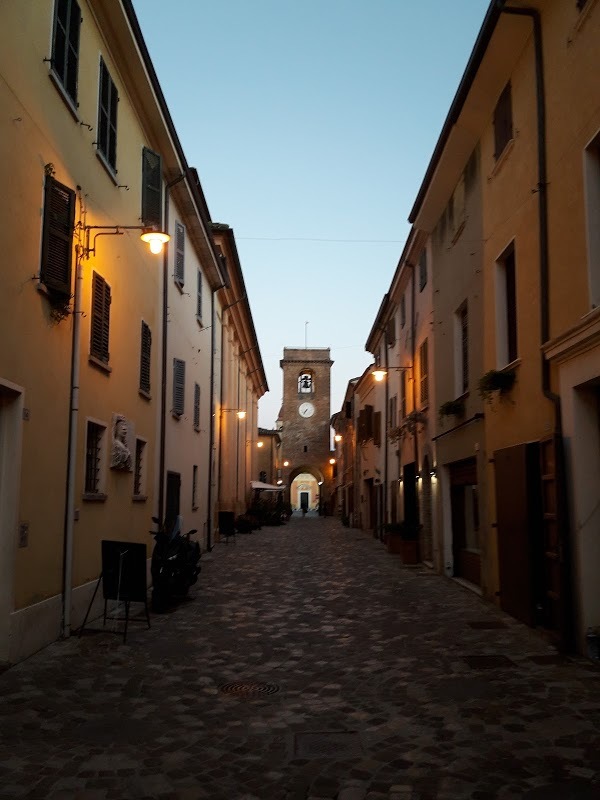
[279,347,333,510]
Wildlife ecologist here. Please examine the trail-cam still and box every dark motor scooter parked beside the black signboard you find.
[150,517,201,614]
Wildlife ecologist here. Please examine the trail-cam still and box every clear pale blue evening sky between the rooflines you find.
[134,0,489,428]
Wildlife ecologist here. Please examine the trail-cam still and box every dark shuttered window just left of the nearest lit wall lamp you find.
[40,175,75,297]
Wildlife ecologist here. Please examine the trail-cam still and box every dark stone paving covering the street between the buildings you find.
[0,516,600,800]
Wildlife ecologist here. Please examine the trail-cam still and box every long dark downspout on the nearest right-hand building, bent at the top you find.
[500,6,572,648]
